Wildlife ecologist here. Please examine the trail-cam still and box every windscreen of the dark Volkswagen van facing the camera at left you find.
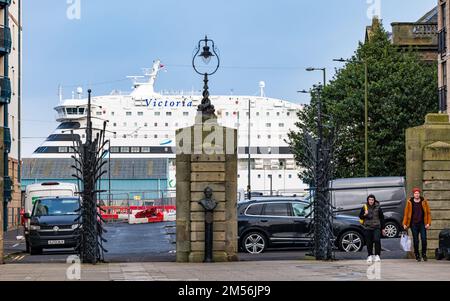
[33,199,80,217]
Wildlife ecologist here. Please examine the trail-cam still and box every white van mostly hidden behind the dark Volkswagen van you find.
[24,182,78,252]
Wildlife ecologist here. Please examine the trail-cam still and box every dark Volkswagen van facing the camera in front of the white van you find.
[25,197,81,255]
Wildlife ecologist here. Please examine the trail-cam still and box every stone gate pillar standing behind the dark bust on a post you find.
[176,116,238,262]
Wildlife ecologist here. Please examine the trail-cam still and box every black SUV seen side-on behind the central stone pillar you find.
[238,197,365,254]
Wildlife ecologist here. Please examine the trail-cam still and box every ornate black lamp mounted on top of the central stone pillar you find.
[192,36,220,117]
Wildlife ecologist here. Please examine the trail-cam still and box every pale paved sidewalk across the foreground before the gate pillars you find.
[0,260,450,281]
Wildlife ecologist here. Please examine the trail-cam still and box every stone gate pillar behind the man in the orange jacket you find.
[406,114,450,258]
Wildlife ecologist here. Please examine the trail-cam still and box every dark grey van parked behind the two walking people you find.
[330,177,406,238]
